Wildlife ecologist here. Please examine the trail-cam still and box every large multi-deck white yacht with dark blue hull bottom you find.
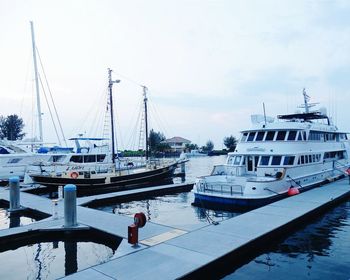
[193,90,350,207]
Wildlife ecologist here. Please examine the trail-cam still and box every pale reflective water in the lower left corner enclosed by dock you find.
[0,241,113,280]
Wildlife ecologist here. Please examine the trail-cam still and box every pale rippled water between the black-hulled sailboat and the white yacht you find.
[97,156,239,230]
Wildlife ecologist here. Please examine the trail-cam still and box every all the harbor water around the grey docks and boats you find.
[0,156,350,280]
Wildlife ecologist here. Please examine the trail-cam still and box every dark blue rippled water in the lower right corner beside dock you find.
[225,201,350,279]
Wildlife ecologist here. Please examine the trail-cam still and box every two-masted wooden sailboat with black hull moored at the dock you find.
[28,69,180,190]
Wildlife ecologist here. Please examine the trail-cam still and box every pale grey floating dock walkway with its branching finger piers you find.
[0,179,350,280]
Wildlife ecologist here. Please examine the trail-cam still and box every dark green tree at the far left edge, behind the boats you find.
[0,115,25,141]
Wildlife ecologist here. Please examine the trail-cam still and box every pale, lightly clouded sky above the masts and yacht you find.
[0,0,350,149]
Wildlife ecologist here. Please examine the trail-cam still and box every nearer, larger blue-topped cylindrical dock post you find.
[64,184,77,227]
